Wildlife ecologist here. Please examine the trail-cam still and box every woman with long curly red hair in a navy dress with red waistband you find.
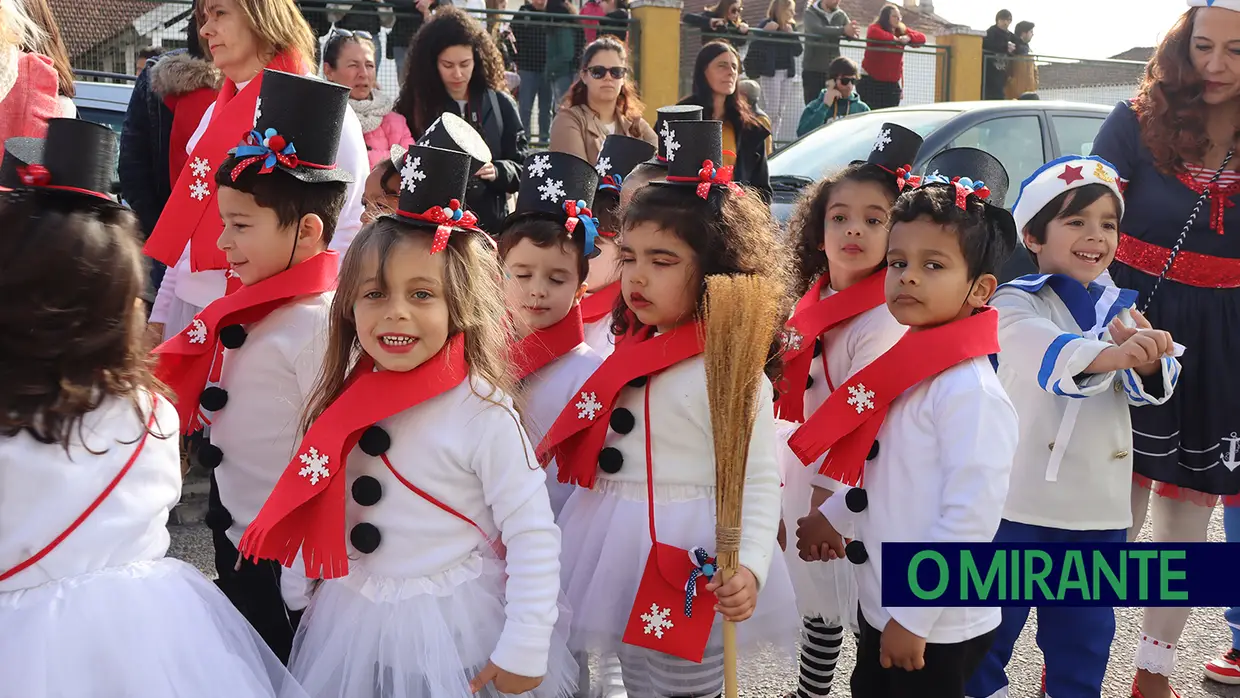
[1094,0,1240,698]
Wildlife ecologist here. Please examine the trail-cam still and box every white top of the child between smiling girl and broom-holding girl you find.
[521,342,603,518]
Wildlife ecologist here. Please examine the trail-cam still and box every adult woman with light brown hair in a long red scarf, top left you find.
[144,0,370,338]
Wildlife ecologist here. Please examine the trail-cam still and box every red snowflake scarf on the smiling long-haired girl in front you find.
[238,334,469,579]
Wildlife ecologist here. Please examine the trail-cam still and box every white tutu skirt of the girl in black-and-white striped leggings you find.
[779,433,858,632]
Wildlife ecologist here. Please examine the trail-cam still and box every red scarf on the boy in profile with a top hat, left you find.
[154,252,340,434]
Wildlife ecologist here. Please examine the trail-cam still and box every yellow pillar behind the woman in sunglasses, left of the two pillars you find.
[630,0,683,124]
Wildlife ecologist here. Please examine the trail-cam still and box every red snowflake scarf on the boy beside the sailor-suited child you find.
[787,307,999,485]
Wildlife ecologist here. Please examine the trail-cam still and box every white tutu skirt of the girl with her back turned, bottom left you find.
[0,558,305,698]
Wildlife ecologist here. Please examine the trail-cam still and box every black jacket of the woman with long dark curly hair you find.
[419,89,529,237]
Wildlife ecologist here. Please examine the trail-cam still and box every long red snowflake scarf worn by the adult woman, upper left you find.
[143,52,306,272]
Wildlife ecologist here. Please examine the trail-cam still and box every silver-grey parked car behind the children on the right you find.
[770,100,1111,280]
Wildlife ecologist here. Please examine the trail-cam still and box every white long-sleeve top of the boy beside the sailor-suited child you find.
[820,357,1018,643]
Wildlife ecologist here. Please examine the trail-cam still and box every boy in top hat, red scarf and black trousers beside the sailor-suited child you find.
[789,149,1018,698]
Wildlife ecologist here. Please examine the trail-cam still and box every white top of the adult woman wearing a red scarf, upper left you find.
[150,83,370,324]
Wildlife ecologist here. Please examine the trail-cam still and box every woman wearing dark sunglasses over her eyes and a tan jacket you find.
[551,36,658,164]
